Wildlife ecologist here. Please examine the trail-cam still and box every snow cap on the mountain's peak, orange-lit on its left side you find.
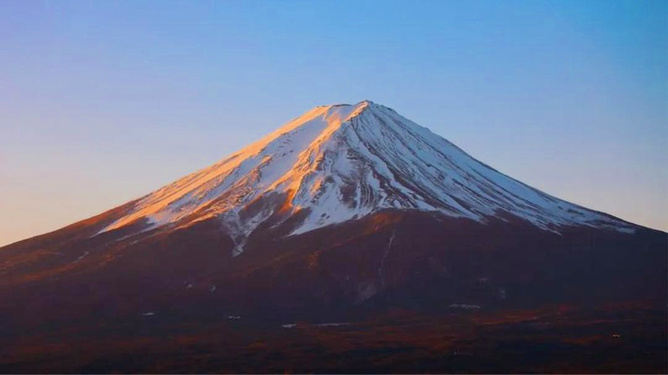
[98,101,634,254]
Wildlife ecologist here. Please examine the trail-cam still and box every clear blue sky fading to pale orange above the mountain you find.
[0,0,668,245]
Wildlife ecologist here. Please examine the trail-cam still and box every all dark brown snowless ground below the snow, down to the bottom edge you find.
[0,209,668,373]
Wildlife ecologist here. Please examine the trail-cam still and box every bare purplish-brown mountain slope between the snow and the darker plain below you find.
[0,210,667,326]
